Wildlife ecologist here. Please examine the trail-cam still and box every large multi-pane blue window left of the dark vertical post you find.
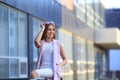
[0,3,28,79]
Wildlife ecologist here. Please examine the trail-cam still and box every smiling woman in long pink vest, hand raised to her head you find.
[30,22,67,80]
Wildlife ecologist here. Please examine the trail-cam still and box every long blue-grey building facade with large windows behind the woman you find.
[0,0,107,80]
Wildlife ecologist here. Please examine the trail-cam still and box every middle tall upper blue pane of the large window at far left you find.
[9,10,18,56]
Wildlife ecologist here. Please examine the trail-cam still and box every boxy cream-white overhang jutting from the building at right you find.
[94,28,120,49]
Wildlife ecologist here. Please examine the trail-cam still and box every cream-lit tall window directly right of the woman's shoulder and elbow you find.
[58,29,73,80]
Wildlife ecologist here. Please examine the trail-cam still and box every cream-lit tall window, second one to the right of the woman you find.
[74,35,86,80]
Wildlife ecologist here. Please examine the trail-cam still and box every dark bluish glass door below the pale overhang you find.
[95,48,107,80]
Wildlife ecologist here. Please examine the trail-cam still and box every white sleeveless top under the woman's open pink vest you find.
[40,41,53,69]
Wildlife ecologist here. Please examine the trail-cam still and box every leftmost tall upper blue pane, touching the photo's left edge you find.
[0,5,8,56]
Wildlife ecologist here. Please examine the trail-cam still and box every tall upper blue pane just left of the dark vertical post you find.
[18,13,28,57]
